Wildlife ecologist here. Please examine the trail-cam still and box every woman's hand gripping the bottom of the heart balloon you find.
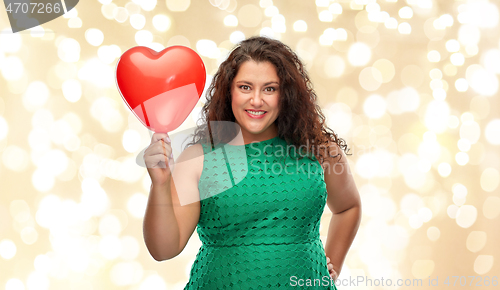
[144,133,173,185]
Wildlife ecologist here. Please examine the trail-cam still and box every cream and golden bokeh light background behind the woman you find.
[0,0,500,290]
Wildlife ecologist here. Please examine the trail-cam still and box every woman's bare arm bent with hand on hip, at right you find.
[323,144,361,274]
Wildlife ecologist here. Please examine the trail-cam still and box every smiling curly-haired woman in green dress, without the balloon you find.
[144,37,361,289]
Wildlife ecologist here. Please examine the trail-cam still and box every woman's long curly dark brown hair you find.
[188,36,350,164]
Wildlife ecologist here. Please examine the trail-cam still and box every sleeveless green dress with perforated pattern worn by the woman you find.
[184,137,337,290]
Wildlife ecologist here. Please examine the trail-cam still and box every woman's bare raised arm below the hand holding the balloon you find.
[143,145,203,261]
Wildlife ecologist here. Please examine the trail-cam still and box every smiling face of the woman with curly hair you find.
[231,60,280,141]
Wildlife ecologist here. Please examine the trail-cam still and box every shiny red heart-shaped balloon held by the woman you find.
[116,46,206,133]
